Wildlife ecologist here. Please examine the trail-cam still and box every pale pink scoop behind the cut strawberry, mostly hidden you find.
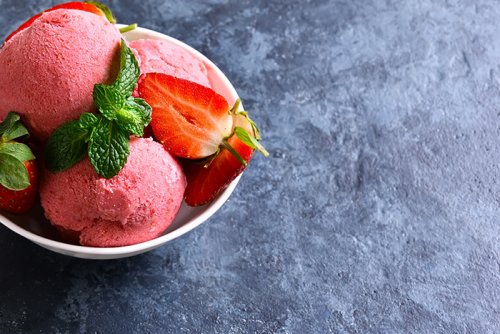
[129,39,210,87]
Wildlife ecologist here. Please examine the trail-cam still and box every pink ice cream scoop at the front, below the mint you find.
[40,138,186,247]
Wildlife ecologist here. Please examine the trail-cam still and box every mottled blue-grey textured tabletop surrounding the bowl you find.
[0,0,500,333]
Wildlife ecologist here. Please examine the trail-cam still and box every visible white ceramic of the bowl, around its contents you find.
[0,25,241,260]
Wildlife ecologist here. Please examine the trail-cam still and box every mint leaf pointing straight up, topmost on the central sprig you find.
[112,39,141,97]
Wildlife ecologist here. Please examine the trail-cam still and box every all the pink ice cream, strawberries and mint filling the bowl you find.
[0,2,267,247]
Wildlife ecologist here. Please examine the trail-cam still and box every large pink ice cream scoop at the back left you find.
[0,9,121,140]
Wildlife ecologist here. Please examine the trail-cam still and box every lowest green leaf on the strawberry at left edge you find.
[0,153,30,190]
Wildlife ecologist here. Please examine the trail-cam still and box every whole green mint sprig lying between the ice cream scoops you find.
[45,40,151,178]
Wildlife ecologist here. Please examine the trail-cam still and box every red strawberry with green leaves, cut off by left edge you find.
[0,112,38,213]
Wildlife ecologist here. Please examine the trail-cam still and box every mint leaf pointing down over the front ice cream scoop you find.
[89,118,130,179]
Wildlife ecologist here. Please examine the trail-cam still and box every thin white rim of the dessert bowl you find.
[0,24,242,259]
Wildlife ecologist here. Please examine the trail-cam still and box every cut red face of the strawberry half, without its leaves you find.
[138,73,233,159]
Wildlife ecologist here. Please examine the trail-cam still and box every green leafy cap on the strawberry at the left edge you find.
[0,112,35,190]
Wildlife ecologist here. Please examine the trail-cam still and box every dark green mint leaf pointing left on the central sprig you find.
[45,121,89,172]
